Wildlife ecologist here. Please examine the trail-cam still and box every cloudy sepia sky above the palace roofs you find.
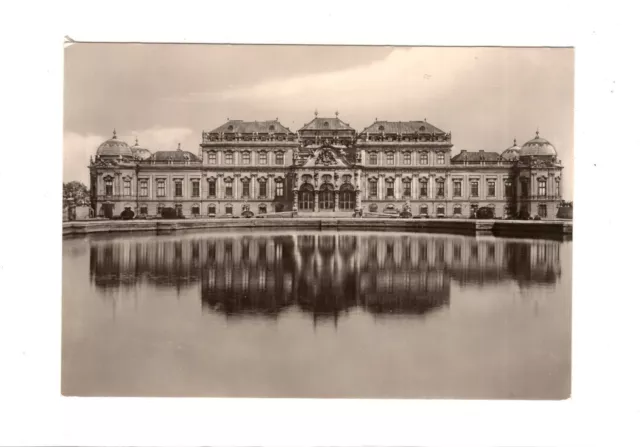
[63,43,574,200]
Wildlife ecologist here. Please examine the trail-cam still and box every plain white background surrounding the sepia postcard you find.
[0,0,640,446]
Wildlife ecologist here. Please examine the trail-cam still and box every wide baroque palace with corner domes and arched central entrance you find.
[89,111,563,219]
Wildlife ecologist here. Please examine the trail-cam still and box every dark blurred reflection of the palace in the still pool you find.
[90,233,561,319]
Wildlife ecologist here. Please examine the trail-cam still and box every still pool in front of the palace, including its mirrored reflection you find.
[62,230,572,399]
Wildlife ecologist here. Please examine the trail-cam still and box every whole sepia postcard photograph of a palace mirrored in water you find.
[61,42,575,400]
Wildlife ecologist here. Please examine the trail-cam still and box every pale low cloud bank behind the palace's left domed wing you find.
[63,126,198,185]
